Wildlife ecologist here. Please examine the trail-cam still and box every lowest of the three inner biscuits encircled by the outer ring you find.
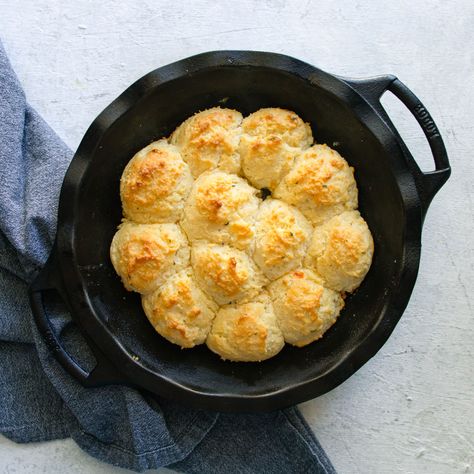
[191,243,266,304]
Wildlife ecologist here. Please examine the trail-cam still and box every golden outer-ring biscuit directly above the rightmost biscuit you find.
[273,145,357,225]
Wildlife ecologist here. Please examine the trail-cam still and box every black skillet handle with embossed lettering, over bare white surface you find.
[346,75,451,217]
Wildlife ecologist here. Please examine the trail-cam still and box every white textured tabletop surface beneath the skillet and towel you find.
[0,0,474,474]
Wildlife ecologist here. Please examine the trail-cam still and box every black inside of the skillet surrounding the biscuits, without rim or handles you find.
[74,66,406,396]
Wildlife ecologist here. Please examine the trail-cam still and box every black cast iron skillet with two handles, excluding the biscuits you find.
[30,51,450,412]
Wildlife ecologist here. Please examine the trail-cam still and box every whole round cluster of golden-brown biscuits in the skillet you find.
[110,108,373,361]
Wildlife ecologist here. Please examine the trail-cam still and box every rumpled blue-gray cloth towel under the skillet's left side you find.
[0,39,335,473]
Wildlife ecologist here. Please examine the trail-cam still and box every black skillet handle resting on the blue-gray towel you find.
[29,247,123,387]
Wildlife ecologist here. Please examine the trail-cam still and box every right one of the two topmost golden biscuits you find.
[240,108,313,191]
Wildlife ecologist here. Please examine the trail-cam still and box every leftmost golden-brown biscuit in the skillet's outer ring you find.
[110,221,189,294]
